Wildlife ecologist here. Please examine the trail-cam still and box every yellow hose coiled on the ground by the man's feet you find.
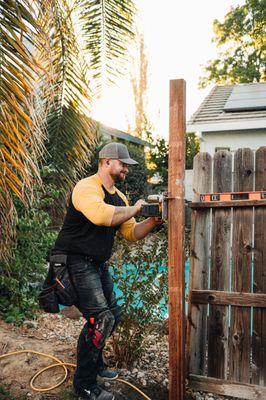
[0,350,151,400]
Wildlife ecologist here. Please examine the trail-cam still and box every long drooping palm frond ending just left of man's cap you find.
[39,0,96,188]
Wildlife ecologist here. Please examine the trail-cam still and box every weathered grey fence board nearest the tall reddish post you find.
[187,153,212,374]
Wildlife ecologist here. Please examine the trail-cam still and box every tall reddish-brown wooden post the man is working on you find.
[168,79,186,400]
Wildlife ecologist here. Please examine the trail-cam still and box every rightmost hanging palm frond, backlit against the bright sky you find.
[76,0,136,90]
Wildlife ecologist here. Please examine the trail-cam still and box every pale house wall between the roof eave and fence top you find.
[200,128,266,155]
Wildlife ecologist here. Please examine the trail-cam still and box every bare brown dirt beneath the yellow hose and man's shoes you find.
[0,320,168,400]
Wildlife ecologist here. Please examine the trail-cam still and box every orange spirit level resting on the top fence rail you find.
[200,191,266,203]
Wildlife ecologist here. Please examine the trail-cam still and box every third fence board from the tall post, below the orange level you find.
[229,149,254,383]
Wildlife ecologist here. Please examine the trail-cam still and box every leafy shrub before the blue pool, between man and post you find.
[107,227,168,367]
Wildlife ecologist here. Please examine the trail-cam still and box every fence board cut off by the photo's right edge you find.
[252,147,266,386]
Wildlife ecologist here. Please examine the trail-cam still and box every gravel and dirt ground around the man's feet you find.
[0,308,244,400]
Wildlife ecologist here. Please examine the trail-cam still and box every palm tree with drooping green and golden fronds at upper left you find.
[0,0,135,258]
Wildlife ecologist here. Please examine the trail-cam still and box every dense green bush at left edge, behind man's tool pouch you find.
[0,173,58,324]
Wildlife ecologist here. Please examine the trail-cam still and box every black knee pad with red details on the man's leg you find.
[89,310,115,349]
